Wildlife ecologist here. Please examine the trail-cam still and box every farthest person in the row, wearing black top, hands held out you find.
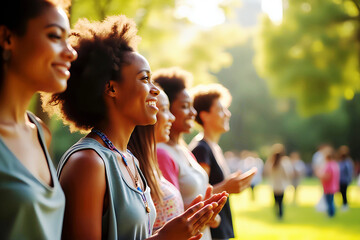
[189,84,256,239]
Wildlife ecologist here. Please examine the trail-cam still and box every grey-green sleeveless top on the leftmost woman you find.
[0,113,65,240]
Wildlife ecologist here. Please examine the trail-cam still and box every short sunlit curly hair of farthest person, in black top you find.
[190,83,232,125]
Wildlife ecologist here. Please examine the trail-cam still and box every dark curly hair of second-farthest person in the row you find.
[152,67,193,106]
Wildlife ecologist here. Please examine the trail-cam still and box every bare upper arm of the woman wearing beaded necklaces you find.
[60,150,106,240]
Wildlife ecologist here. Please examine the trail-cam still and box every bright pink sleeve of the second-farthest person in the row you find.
[156,148,180,189]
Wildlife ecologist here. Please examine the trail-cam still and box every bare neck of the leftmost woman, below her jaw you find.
[0,74,36,124]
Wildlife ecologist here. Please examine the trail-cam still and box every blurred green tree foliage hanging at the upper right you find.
[255,0,360,115]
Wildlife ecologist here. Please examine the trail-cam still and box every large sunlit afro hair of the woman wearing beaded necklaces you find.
[43,15,140,131]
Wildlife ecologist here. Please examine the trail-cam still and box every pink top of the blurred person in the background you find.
[322,160,340,194]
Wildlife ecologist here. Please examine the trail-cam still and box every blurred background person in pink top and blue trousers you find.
[316,146,340,217]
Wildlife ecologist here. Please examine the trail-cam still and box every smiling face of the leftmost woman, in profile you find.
[7,7,77,92]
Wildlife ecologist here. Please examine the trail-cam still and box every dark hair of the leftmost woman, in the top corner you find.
[0,0,71,90]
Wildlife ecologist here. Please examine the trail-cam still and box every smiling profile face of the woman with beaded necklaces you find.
[116,52,159,125]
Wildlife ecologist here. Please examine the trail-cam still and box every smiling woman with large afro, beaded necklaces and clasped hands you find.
[43,16,221,240]
